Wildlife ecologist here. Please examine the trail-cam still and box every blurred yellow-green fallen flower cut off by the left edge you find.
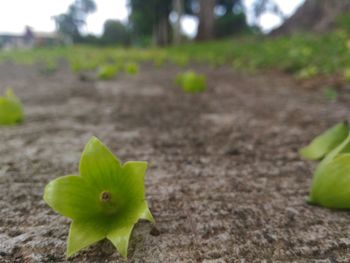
[0,89,23,125]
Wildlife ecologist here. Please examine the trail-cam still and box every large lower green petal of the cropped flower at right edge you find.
[310,153,350,209]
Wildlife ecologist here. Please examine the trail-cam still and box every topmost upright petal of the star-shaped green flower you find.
[79,137,121,190]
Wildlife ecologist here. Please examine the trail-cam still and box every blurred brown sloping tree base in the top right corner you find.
[271,0,350,34]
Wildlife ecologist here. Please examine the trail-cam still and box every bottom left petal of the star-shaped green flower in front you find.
[66,219,109,257]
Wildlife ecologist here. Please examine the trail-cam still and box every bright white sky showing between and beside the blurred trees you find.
[0,0,304,35]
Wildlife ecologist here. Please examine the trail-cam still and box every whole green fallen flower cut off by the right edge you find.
[304,123,350,209]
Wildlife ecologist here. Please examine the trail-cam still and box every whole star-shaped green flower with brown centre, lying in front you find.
[44,137,154,257]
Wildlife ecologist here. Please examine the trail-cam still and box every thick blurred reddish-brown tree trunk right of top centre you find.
[197,0,216,41]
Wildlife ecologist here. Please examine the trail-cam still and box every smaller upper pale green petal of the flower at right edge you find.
[299,122,349,160]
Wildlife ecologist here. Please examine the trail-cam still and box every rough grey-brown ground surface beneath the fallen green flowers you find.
[0,64,350,263]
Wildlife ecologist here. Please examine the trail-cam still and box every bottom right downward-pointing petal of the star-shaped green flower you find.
[107,224,134,258]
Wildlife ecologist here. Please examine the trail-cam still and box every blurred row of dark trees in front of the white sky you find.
[54,0,279,46]
